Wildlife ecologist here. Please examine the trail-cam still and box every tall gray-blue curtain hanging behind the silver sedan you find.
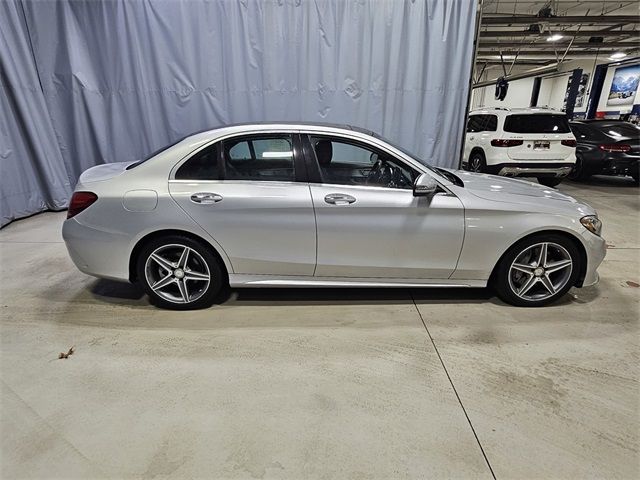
[0,0,476,224]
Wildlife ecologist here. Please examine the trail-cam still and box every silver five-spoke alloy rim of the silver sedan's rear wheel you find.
[144,243,211,303]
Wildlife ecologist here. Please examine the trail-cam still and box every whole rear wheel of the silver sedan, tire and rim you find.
[136,235,228,310]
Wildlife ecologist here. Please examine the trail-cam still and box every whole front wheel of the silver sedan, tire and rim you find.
[493,234,580,307]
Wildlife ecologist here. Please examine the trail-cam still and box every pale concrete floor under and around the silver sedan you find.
[0,179,640,479]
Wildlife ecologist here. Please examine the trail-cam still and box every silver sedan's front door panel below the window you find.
[310,184,464,279]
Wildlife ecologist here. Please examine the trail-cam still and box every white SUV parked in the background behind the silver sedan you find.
[462,108,576,187]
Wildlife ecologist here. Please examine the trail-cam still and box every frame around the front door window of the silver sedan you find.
[300,132,424,194]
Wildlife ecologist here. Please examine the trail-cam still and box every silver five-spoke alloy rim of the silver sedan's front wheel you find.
[509,242,573,301]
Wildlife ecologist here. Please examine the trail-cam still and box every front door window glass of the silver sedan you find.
[310,136,419,189]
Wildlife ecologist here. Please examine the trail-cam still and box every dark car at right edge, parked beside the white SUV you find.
[569,120,640,184]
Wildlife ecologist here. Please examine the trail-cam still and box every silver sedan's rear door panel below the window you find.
[169,180,316,275]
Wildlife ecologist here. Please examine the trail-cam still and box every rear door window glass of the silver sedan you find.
[224,134,295,182]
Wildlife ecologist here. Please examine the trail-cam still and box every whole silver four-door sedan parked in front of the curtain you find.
[62,124,605,309]
